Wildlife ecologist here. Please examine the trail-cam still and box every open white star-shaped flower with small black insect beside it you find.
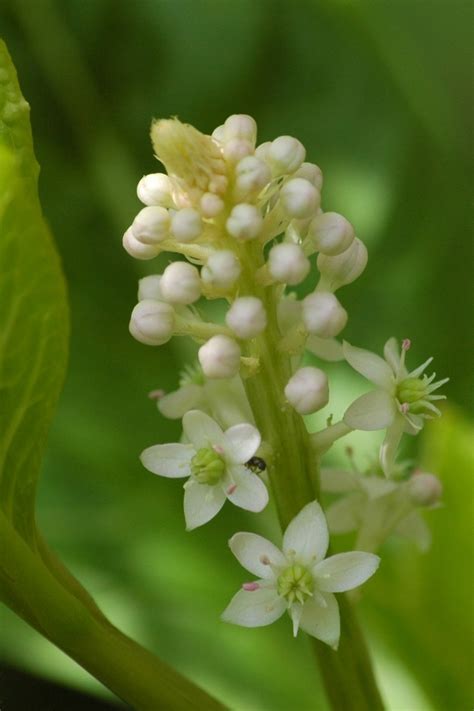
[140,410,268,531]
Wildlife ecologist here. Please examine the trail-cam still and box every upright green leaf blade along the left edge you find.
[0,43,69,544]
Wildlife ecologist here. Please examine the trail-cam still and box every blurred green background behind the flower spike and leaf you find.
[0,0,473,711]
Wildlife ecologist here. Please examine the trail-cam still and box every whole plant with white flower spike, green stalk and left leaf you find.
[0,37,445,710]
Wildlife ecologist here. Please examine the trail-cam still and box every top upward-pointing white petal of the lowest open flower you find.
[283,501,329,565]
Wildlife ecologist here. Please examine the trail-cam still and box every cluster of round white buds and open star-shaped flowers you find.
[123,115,446,647]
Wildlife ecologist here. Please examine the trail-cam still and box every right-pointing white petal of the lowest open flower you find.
[313,551,380,592]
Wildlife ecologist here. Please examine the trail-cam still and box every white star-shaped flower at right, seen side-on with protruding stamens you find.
[343,338,449,476]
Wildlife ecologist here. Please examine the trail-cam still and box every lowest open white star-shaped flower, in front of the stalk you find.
[222,501,380,649]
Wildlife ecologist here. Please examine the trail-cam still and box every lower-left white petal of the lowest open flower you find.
[221,587,286,627]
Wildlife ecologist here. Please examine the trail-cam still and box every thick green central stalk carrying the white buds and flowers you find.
[241,253,383,711]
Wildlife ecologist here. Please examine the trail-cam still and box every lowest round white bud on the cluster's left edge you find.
[129,299,174,346]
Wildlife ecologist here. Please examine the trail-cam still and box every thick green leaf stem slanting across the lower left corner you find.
[0,512,224,711]
